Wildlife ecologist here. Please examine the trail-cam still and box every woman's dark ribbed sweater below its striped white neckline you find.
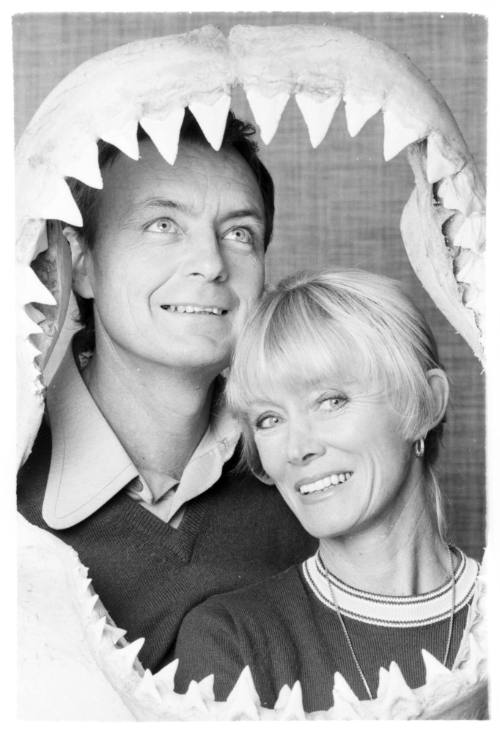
[175,567,468,712]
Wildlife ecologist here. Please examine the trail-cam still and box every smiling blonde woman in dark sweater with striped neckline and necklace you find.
[176,271,478,712]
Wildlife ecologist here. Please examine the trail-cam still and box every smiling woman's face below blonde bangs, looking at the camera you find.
[249,380,421,538]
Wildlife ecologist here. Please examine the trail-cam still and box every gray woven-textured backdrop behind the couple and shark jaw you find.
[13,12,487,558]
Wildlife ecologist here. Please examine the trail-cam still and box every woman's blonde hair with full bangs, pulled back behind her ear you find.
[226,270,450,534]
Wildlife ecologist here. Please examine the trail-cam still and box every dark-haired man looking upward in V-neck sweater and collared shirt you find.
[18,111,314,671]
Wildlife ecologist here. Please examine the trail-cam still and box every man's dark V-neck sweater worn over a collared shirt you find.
[18,420,317,671]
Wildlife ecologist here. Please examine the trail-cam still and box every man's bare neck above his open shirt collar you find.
[83,340,217,492]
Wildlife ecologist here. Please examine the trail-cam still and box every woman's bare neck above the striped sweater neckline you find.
[320,491,451,595]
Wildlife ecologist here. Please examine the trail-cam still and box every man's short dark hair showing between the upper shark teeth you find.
[68,107,274,337]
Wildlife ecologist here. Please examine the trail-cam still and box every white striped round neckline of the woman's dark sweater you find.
[302,548,479,628]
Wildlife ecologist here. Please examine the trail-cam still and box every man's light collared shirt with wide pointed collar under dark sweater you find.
[42,346,239,529]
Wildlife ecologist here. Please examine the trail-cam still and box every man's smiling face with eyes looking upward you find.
[83,141,264,374]
